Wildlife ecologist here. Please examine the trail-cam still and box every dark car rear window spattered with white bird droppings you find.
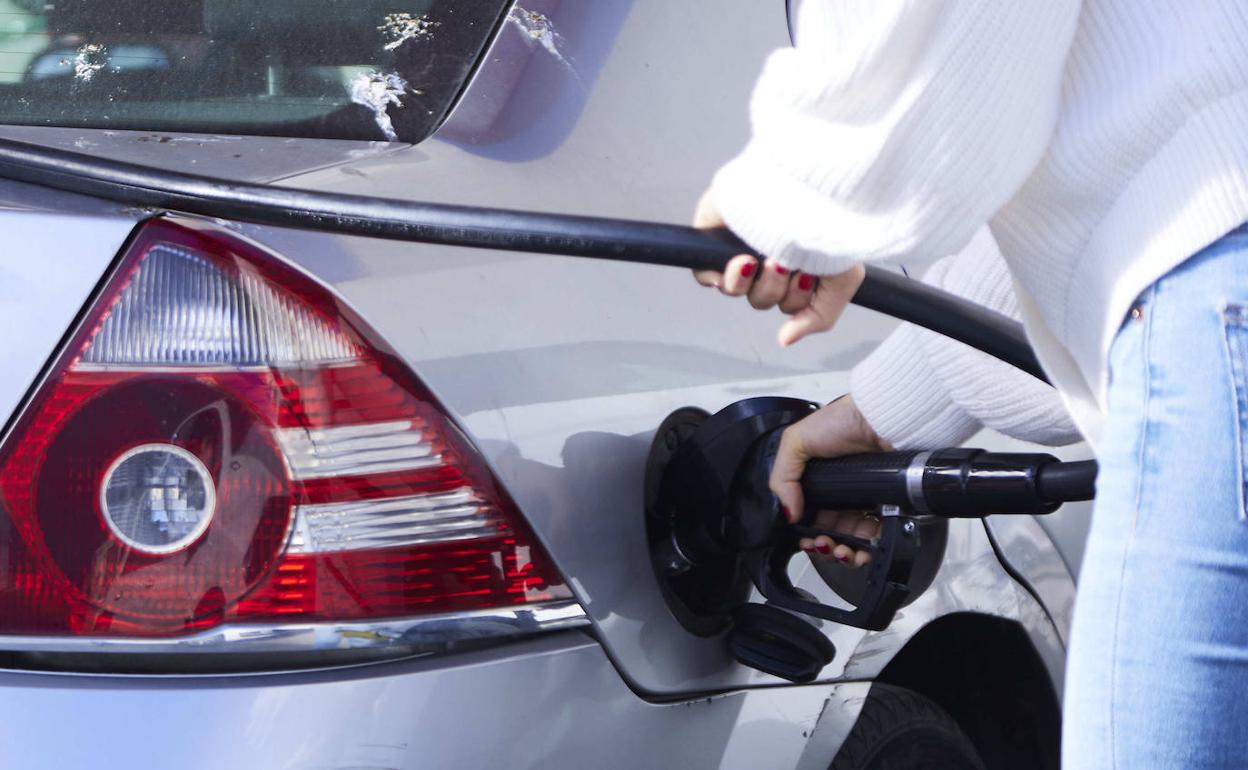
[0,0,509,142]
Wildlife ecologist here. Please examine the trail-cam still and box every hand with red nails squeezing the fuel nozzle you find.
[769,394,892,567]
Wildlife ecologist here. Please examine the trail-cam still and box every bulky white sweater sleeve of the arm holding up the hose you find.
[711,0,1080,275]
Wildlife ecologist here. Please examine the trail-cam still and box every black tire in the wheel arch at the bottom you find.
[830,684,985,770]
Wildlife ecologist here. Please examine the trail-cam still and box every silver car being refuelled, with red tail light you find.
[0,0,1087,770]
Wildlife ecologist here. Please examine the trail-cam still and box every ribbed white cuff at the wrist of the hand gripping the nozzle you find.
[850,324,981,449]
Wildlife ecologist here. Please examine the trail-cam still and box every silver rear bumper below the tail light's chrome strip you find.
[0,631,834,770]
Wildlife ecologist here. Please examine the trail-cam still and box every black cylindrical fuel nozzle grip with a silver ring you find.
[801,448,1096,523]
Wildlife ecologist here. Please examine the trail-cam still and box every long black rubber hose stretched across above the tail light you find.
[0,139,1048,382]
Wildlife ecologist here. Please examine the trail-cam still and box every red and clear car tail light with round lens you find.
[0,213,582,649]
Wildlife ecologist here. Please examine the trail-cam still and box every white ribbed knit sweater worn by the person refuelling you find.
[713,0,1248,447]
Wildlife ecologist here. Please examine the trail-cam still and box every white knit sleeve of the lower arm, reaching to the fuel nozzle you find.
[850,227,1080,449]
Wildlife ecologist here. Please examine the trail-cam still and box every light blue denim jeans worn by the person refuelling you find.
[1062,228,1248,770]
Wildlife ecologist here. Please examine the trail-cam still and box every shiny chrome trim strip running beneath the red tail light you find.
[0,599,589,654]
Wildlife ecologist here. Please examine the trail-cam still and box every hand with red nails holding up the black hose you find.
[694,192,866,347]
